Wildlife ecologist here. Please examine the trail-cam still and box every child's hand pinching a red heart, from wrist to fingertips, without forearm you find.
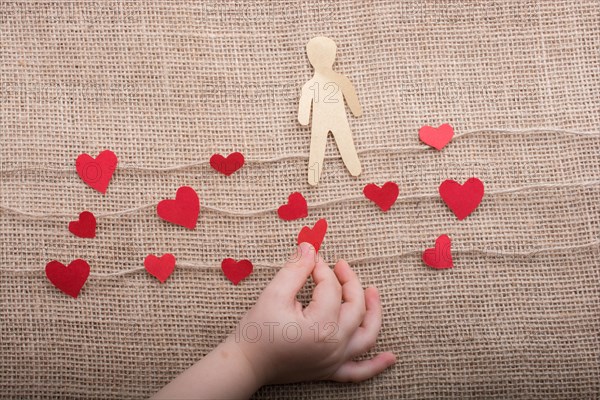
[227,243,396,385]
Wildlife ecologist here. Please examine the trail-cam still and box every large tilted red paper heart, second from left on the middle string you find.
[156,186,200,229]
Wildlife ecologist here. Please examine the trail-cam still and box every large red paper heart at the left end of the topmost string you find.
[75,150,118,194]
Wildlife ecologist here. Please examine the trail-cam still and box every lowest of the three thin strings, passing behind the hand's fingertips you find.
[5,240,600,278]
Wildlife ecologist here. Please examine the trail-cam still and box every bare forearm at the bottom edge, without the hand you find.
[152,340,261,399]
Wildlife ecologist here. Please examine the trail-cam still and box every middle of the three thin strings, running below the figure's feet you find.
[0,180,600,219]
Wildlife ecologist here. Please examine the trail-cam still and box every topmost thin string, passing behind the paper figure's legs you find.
[0,128,600,173]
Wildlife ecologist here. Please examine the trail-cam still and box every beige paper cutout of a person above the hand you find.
[298,37,362,185]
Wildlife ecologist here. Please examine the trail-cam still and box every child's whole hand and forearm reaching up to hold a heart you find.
[153,243,396,399]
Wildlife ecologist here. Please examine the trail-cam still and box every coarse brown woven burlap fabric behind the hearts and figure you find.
[0,0,600,399]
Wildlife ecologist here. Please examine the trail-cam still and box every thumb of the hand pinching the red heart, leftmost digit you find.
[265,242,318,299]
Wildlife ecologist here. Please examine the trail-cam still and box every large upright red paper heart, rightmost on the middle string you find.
[439,178,483,220]
